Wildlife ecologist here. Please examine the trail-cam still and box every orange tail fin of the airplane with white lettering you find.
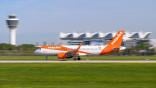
[100,30,125,55]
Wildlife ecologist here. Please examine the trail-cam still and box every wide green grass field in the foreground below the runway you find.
[0,63,156,88]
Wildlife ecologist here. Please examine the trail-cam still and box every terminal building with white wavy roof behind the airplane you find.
[59,32,151,48]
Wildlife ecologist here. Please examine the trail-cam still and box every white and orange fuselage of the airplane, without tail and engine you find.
[35,45,105,55]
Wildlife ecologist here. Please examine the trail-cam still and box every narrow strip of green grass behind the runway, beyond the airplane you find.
[0,56,156,60]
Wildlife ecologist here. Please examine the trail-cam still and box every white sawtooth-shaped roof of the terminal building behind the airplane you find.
[59,32,151,40]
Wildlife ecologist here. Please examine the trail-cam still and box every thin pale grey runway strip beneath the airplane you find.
[0,60,156,64]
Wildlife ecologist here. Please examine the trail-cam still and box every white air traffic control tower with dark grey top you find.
[6,15,19,45]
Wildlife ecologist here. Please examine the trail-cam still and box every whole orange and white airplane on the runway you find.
[34,30,125,60]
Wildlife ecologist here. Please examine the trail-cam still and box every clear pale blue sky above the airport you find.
[0,0,156,44]
